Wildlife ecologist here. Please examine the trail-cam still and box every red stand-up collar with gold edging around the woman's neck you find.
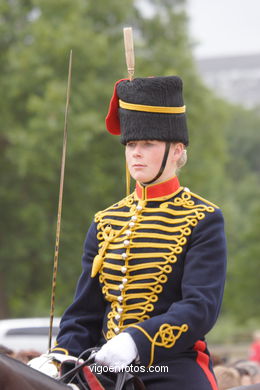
[135,176,180,199]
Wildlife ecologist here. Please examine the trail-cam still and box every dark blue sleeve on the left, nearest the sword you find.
[53,223,105,356]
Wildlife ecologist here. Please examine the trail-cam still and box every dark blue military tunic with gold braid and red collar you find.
[53,177,226,390]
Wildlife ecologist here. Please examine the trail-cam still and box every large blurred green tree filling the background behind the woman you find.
[0,0,259,330]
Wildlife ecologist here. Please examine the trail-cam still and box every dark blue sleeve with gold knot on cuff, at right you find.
[125,209,226,366]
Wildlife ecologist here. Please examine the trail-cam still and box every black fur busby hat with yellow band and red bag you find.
[106,76,188,145]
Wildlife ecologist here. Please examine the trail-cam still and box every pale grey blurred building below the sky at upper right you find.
[197,54,260,108]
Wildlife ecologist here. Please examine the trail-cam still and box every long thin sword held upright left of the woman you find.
[48,50,72,352]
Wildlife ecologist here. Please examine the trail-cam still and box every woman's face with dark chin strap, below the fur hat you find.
[125,140,183,183]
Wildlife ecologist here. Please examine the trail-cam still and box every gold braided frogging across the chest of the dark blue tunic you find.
[95,191,215,344]
